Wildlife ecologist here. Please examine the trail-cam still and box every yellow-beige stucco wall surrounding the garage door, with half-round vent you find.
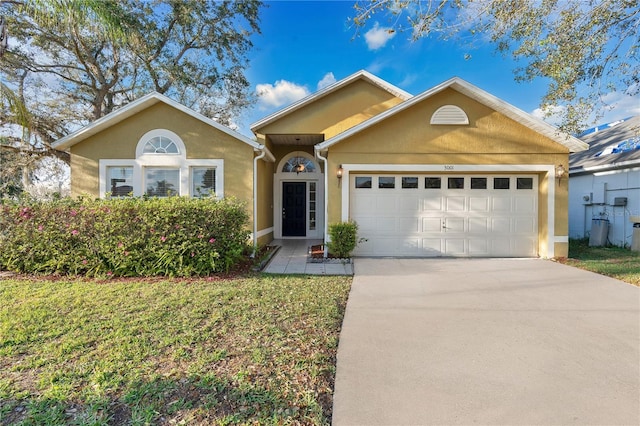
[328,89,569,257]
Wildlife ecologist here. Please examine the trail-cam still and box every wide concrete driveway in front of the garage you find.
[333,258,640,425]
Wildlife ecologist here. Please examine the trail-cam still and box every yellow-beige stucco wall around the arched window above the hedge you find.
[70,103,254,220]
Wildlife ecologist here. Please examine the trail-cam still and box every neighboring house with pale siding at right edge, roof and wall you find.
[569,116,640,247]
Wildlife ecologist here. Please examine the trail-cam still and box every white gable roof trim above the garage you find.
[315,77,588,152]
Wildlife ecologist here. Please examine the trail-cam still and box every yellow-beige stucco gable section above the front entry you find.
[257,80,402,139]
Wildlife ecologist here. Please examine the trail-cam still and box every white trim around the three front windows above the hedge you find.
[99,159,224,198]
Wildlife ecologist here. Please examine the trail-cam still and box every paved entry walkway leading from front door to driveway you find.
[263,240,353,275]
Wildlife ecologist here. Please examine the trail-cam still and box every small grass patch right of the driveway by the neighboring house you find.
[563,240,640,286]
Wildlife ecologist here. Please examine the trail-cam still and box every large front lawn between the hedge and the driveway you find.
[0,276,351,425]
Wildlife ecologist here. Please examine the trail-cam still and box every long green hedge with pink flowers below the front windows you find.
[0,197,250,276]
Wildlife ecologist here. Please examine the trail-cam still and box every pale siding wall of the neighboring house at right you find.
[569,167,640,246]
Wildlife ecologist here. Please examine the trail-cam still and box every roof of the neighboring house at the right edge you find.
[569,115,640,174]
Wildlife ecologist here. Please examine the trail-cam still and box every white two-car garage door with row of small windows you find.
[349,174,538,257]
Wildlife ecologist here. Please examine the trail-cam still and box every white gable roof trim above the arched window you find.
[51,92,264,154]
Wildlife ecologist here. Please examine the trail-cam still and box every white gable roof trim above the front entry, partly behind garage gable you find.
[250,70,412,133]
